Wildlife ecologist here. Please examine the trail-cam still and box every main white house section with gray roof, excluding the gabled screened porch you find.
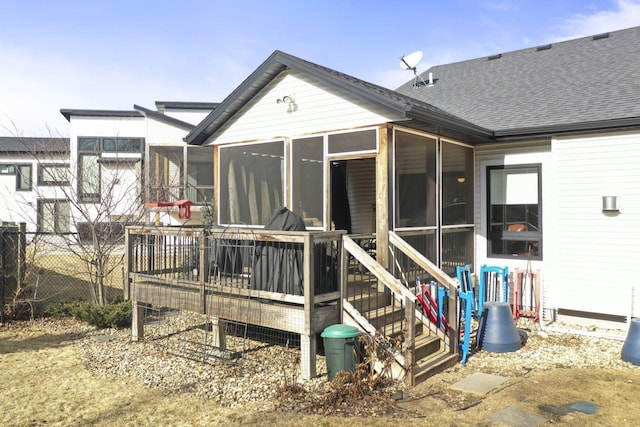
[398,27,640,325]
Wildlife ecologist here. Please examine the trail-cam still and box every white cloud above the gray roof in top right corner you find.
[549,0,640,42]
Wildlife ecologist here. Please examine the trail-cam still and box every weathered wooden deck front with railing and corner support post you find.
[125,227,344,378]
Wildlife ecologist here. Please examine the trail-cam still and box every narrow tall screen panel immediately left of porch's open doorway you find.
[291,136,324,227]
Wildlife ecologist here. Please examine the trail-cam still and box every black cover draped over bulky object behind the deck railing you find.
[253,207,306,295]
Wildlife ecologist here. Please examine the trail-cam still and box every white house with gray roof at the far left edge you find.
[0,137,69,233]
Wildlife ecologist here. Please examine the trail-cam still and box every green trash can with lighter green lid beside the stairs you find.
[320,325,361,380]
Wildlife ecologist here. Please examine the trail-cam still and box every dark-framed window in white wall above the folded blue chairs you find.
[487,164,542,259]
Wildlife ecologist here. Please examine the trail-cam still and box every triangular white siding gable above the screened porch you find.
[209,72,400,144]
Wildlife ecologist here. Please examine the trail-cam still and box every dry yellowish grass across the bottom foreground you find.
[0,320,640,427]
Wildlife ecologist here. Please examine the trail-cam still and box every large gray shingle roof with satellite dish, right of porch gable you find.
[397,27,640,136]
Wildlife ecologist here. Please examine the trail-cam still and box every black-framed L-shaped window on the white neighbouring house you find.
[78,137,144,203]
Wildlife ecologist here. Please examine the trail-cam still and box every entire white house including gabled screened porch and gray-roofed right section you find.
[179,27,640,324]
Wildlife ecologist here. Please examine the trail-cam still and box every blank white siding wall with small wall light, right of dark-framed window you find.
[552,132,640,316]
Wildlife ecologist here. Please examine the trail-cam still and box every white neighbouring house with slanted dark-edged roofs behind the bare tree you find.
[61,101,217,231]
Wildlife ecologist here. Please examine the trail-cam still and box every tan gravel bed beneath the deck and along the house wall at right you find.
[55,320,637,416]
